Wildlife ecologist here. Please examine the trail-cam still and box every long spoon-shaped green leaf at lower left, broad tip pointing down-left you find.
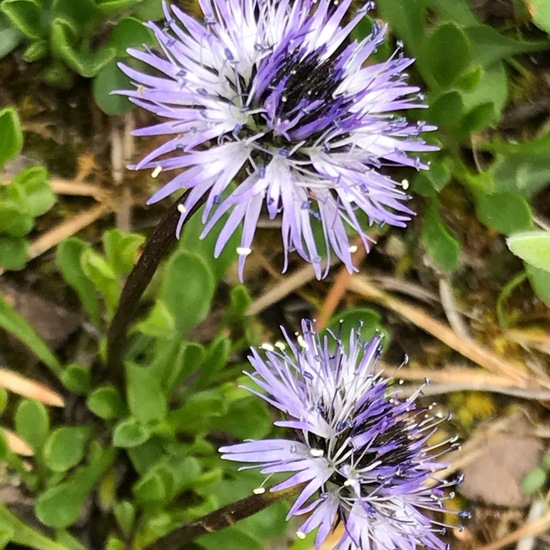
[35,443,115,529]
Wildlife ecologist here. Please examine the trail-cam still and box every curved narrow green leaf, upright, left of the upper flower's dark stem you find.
[55,237,99,324]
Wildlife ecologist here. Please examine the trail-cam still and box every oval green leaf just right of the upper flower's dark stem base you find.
[126,365,167,423]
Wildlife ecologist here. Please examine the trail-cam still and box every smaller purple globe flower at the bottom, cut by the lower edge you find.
[220,321,466,550]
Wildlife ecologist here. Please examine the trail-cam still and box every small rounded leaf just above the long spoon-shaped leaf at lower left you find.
[42,426,90,472]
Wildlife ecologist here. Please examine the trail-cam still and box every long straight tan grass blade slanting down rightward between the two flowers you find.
[349,275,531,388]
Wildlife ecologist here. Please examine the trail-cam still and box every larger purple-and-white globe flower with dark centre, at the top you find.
[121,0,435,279]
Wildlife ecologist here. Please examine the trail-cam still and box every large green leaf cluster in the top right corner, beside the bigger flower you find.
[378,0,550,312]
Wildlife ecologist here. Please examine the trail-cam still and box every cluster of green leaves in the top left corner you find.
[0,0,162,115]
